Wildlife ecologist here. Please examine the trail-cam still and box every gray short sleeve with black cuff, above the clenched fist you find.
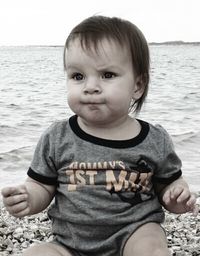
[27,125,57,185]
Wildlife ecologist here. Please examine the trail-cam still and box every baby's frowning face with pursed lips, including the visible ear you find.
[65,38,143,126]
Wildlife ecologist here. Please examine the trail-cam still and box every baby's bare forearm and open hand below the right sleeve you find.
[157,177,199,215]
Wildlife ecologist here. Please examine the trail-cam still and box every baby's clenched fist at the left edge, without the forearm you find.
[1,185,30,217]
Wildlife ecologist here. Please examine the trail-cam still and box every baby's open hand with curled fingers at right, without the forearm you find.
[162,184,199,216]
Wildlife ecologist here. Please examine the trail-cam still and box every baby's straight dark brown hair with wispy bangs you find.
[64,16,150,112]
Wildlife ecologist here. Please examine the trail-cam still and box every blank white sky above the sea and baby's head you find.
[0,0,200,46]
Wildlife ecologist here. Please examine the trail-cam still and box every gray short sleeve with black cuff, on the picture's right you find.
[153,125,182,184]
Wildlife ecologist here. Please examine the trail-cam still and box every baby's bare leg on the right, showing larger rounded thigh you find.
[123,222,171,256]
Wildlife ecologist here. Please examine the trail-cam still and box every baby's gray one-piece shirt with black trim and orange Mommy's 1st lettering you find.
[28,116,181,256]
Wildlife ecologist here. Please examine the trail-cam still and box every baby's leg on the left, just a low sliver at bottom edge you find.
[22,243,73,256]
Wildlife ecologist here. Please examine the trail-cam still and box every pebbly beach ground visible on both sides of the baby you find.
[0,196,200,256]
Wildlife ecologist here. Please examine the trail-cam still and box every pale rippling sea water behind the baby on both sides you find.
[0,44,200,191]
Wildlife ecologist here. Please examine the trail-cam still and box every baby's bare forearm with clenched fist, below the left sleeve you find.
[1,177,55,217]
